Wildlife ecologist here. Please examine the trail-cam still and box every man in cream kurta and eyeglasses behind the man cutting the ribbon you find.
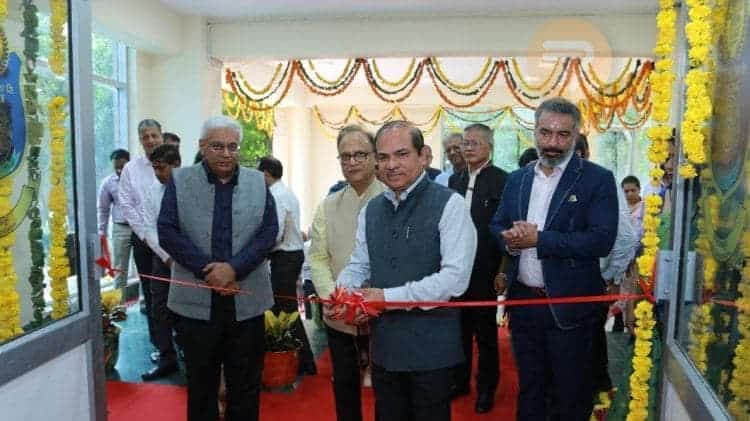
[310,126,383,421]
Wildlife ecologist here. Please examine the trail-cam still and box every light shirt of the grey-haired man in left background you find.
[117,156,156,240]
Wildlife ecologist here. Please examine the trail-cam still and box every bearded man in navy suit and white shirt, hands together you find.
[490,98,619,421]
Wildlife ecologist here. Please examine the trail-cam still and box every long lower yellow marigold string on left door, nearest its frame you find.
[48,96,70,319]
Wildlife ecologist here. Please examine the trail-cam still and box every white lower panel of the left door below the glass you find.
[0,345,91,421]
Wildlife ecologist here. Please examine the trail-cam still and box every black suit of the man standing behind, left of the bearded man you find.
[448,162,507,395]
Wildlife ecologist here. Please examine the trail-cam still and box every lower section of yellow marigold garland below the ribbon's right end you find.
[626,300,656,421]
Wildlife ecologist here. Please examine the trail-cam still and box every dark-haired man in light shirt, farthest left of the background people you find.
[98,149,132,302]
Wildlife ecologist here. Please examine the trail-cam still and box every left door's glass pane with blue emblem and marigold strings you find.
[0,0,80,344]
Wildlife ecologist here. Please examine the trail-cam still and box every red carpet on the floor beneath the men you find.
[107,329,518,421]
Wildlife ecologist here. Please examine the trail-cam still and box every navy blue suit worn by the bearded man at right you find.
[490,154,618,421]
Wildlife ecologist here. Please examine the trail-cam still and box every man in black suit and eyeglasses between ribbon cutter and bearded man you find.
[448,124,507,414]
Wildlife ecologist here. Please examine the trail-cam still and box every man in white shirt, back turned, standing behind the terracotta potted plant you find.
[258,156,317,375]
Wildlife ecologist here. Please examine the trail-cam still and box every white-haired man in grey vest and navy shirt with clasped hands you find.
[158,116,278,421]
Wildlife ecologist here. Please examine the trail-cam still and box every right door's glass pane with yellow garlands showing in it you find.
[676,0,750,419]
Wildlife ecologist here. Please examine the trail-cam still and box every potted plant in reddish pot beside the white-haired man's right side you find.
[263,310,300,388]
